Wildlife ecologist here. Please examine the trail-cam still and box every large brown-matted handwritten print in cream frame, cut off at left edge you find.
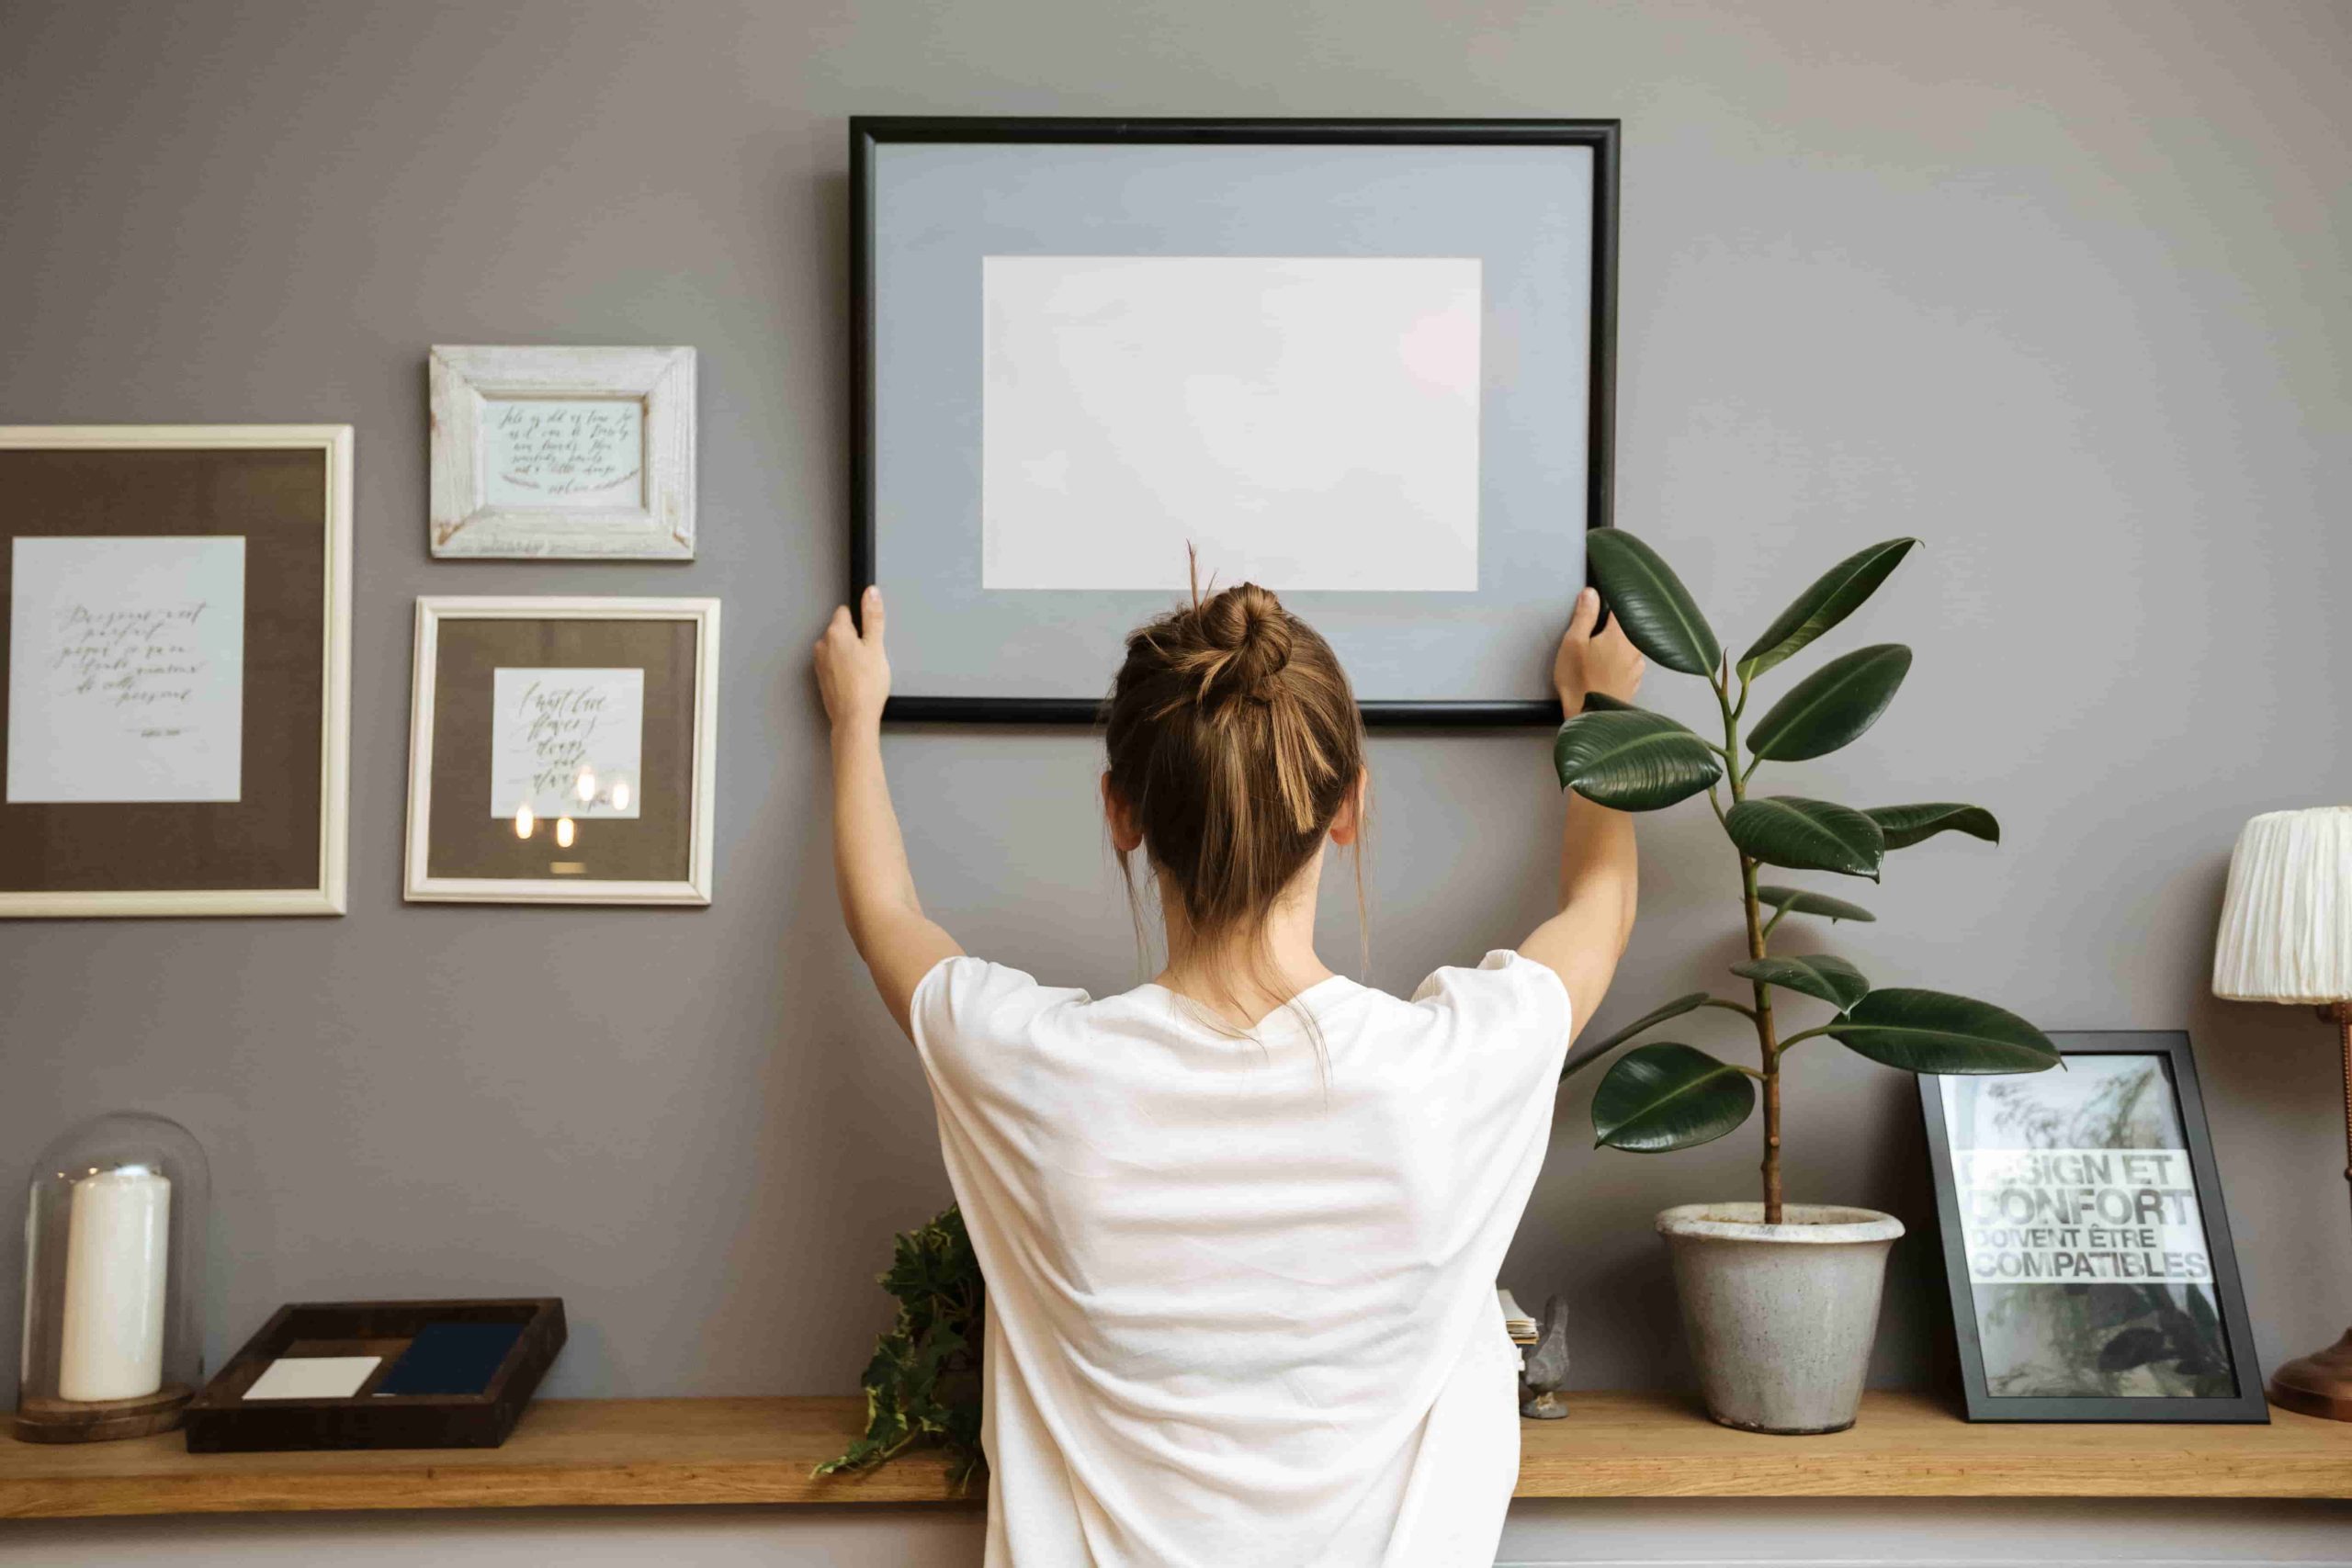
[0,425,353,917]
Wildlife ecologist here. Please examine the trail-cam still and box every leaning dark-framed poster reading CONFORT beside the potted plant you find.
[1919,1032,2269,1422]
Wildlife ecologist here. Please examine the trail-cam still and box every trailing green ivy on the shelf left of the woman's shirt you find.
[814,1206,988,1491]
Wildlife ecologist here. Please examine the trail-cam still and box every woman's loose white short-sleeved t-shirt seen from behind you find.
[915,952,1569,1568]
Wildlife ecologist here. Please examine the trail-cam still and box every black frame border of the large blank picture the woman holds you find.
[849,115,1621,727]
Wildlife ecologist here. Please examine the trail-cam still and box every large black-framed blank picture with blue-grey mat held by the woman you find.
[849,118,1618,724]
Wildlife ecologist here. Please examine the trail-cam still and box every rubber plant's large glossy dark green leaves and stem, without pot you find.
[1553,529,2058,1224]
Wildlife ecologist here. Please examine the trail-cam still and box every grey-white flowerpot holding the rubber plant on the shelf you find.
[1658,1203,1903,1434]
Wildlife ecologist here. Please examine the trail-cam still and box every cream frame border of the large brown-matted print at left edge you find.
[0,425,353,919]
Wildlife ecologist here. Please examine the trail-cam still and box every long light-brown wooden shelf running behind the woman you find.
[0,1394,2352,1518]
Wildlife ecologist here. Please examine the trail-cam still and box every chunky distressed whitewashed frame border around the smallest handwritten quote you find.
[425,345,694,562]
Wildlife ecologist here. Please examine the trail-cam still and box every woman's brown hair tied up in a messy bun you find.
[1103,570,1364,1025]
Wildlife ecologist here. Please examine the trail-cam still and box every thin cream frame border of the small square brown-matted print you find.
[402,594,719,905]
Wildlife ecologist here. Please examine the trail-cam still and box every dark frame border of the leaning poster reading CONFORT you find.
[1917,1030,2269,1422]
